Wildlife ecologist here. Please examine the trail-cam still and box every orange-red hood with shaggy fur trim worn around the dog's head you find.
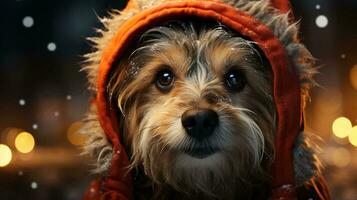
[81,0,328,199]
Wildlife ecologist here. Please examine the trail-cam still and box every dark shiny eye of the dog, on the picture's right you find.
[224,69,246,92]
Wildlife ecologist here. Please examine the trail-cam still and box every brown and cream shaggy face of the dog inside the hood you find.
[108,23,275,197]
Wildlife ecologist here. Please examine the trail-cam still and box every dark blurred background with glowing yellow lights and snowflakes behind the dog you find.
[0,0,357,200]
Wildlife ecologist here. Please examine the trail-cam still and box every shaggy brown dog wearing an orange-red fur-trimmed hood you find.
[81,0,328,200]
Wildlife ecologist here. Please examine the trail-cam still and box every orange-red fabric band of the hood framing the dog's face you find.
[83,0,312,200]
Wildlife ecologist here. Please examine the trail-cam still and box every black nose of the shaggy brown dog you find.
[181,109,218,139]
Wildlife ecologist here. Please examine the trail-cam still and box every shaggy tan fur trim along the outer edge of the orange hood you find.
[81,0,320,184]
